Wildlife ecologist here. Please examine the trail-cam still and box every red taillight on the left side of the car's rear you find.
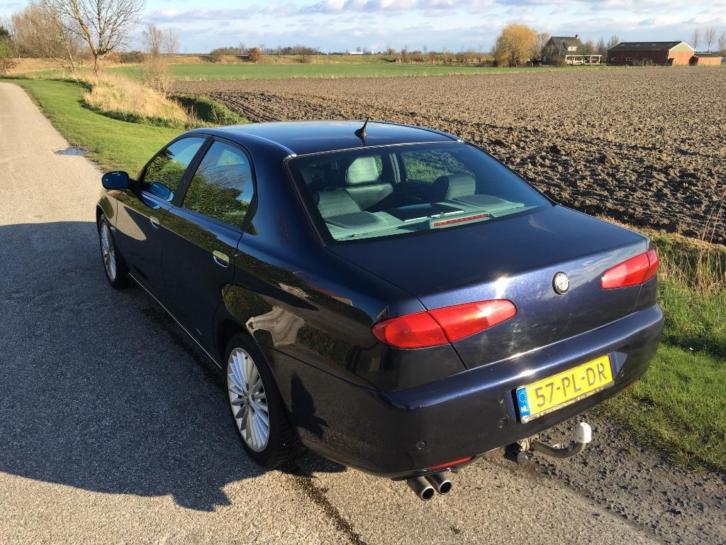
[373,299,517,348]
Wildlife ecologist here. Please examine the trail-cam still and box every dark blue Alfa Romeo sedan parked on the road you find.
[97,122,663,498]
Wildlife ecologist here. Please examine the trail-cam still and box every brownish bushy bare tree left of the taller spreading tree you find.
[12,2,83,72]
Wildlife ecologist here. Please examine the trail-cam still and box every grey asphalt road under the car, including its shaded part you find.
[0,83,712,545]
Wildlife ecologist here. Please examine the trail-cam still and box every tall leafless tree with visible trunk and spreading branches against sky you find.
[44,0,144,75]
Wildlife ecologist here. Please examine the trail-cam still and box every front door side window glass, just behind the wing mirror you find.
[141,137,205,202]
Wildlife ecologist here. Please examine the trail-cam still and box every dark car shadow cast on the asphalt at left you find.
[0,221,342,511]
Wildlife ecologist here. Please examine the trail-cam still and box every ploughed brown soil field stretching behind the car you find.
[177,67,726,243]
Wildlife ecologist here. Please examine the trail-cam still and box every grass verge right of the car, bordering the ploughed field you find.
[600,233,726,472]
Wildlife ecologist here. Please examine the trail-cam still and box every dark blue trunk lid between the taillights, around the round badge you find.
[330,206,648,367]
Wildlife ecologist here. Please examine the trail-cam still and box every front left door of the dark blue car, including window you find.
[116,137,206,288]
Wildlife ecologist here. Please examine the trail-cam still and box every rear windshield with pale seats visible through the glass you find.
[289,143,549,241]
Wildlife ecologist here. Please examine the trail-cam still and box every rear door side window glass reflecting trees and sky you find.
[183,142,254,227]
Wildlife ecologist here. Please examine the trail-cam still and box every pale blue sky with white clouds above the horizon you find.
[0,0,726,53]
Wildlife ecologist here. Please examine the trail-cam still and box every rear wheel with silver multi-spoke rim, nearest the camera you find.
[225,334,299,469]
